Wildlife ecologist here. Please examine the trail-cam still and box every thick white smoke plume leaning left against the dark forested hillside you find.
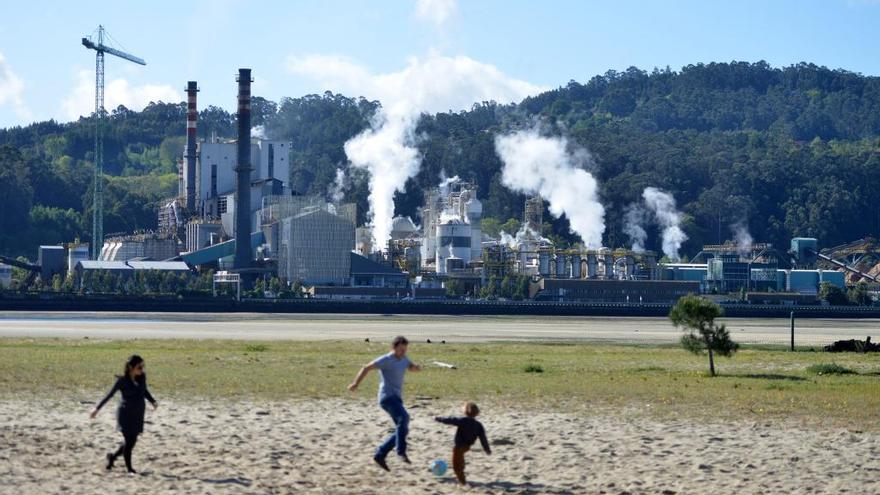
[495,129,605,249]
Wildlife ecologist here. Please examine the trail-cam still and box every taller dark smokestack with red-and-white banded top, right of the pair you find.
[233,69,254,269]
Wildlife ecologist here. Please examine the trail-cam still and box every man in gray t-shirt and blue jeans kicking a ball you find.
[348,337,422,471]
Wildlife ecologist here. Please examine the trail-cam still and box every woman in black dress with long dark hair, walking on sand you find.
[91,354,159,473]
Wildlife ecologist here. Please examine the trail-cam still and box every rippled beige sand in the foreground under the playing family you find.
[0,400,880,494]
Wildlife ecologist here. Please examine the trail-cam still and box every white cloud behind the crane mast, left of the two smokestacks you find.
[61,70,183,120]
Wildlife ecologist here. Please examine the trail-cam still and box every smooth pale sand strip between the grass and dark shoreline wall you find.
[0,312,880,346]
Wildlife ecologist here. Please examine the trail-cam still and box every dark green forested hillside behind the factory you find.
[0,62,880,257]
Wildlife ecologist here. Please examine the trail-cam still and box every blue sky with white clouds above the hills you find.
[0,0,880,127]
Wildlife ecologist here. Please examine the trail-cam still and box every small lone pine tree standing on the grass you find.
[669,295,739,376]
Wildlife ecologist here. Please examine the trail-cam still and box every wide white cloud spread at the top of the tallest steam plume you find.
[287,54,546,113]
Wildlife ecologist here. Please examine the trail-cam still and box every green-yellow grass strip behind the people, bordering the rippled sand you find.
[0,339,880,429]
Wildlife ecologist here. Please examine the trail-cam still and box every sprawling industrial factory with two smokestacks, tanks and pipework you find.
[0,65,868,304]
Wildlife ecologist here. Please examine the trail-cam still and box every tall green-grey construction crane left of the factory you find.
[82,26,147,260]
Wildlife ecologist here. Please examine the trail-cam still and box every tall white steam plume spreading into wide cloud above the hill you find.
[287,54,543,249]
